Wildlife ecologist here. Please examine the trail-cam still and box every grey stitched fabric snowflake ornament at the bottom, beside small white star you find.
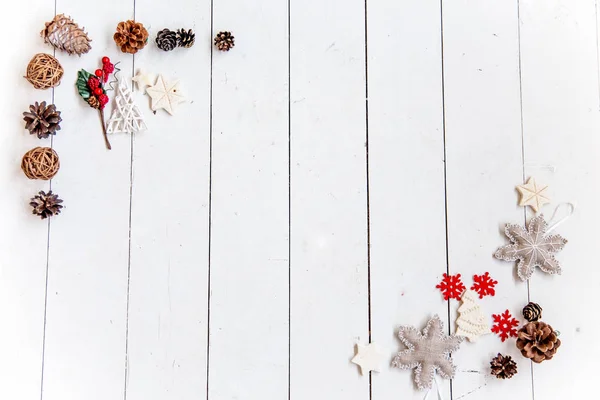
[392,315,463,389]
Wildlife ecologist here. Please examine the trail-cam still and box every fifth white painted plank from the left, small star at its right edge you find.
[290,0,369,400]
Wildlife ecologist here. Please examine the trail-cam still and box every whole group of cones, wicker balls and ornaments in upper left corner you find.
[21,14,235,219]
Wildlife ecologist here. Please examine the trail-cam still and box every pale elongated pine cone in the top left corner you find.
[41,14,92,56]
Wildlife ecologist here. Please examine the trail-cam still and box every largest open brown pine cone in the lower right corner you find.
[517,321,560,363]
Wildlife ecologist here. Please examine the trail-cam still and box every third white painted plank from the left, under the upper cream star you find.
[126,0,211,400]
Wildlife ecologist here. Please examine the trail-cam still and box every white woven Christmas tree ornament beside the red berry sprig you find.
[106,82,148,133]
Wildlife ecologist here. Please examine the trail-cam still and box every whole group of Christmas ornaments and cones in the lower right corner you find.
[352,178,567,390]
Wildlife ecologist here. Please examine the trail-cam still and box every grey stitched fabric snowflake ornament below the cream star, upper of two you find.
[494,214,567,281]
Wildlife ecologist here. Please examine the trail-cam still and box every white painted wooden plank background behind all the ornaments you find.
[0,0,600,400]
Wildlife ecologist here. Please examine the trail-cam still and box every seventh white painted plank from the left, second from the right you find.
[443,0,532,399]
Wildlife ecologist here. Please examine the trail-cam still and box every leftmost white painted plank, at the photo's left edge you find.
[0,0,54,400]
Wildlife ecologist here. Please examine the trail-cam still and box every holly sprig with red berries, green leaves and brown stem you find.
[75,57,115,150]
